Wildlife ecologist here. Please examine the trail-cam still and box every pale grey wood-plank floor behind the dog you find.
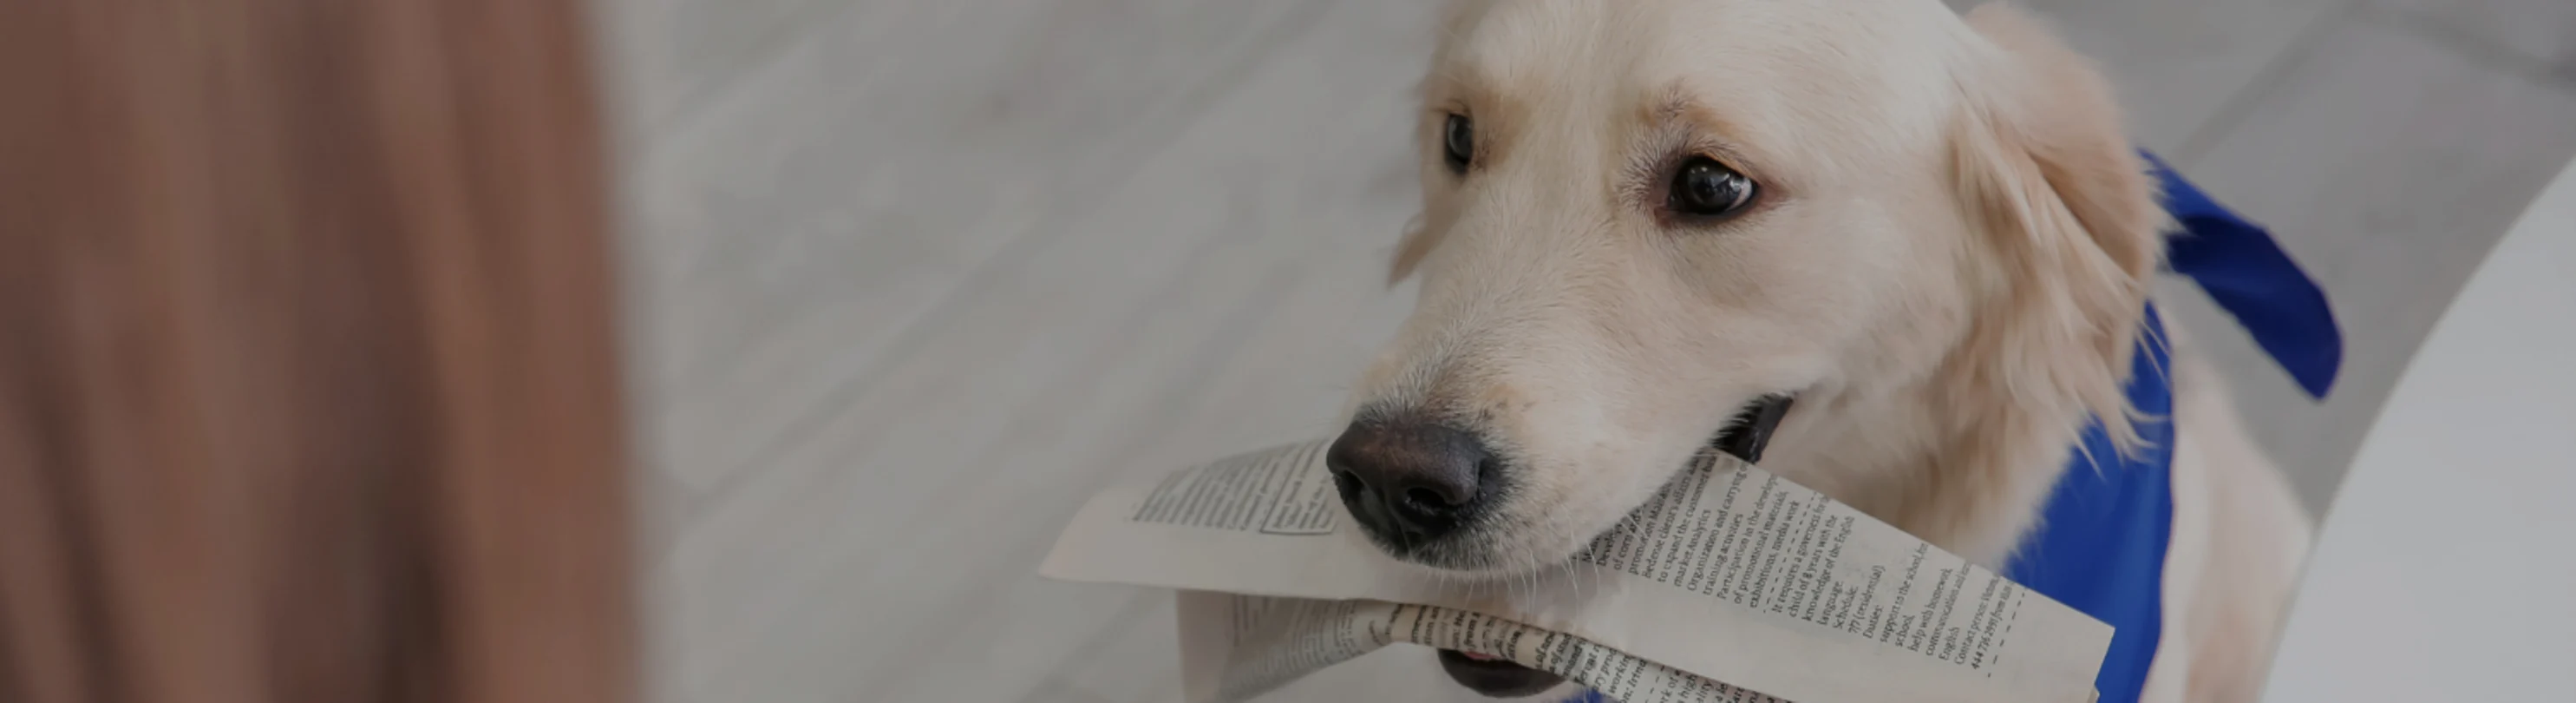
[598,0,2576,703]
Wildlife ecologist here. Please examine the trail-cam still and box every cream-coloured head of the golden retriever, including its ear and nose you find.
[1330,0,2164,575]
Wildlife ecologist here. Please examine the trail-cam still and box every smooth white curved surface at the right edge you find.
[2265,155,2576,703]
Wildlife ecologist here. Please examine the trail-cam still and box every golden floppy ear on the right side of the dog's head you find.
[1952,5,2169,445]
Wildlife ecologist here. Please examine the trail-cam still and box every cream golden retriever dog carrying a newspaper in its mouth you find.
[1330,0,2311,700]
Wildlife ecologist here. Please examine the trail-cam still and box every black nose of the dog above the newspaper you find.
[1324,420,1494,549]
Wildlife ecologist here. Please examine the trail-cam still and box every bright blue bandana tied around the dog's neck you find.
[1569,154,2344,703]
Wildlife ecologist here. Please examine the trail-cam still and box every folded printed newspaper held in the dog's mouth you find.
[1041,440,2109,703]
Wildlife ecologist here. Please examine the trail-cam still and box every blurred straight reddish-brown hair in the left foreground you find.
[0,0,634,703]
